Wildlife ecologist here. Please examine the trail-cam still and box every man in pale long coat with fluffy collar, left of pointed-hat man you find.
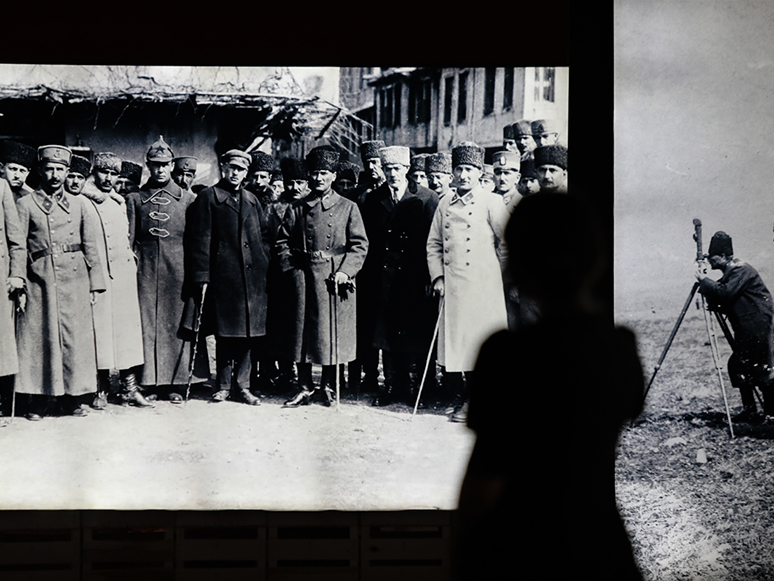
[81,152,153,409]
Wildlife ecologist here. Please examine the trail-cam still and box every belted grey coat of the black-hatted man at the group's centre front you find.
[277,190,368,365]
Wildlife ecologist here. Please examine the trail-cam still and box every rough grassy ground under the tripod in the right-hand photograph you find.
[616,307,774,581]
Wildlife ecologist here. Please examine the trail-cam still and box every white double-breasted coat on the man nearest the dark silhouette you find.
[427,186,509,371]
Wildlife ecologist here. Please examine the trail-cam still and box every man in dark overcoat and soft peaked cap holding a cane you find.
[186,149,270,405]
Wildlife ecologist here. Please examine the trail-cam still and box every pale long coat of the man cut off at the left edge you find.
[0,179,27,377]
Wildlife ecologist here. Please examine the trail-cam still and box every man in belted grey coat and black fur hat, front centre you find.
[277,146,368,407]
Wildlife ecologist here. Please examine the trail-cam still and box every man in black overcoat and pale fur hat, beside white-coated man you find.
[357,146,438,405]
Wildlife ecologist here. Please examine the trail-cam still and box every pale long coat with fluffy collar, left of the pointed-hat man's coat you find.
[81,181,143,370]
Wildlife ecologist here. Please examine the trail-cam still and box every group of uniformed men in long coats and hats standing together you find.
[0,121,567,421]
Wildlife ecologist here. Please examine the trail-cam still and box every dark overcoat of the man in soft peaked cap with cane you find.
[186,182,270,337]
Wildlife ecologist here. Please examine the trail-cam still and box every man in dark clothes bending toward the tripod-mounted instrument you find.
[696,231,774,422]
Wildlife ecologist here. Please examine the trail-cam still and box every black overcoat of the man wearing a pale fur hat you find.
[358,183,438,354]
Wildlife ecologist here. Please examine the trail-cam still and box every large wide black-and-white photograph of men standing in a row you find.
[0,63,569,511]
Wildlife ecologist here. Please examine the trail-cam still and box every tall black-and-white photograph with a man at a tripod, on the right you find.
[614,0,774,580]
